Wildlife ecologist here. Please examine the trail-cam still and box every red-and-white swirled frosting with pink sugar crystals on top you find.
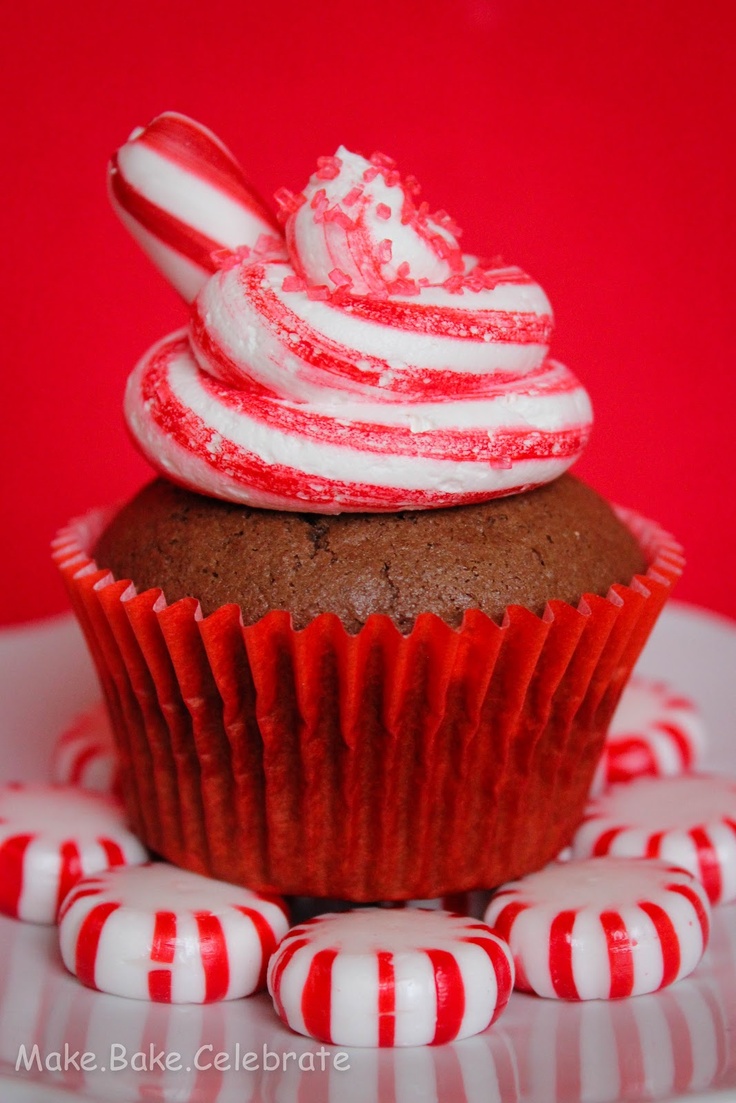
[117,116,591,513]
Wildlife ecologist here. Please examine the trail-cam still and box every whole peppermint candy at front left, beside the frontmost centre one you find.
[58,861,289,1004]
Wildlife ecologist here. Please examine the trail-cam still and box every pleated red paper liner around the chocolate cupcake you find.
[54,511,682,901]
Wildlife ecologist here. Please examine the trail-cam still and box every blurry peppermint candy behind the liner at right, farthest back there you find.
[605,677,705,783]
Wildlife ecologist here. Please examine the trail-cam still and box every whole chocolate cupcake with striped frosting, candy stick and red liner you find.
[55,114,681,901]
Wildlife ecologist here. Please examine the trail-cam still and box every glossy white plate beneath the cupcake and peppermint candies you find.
[0,603,736,1103]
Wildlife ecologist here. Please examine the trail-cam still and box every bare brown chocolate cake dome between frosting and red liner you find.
[95,474,647,633]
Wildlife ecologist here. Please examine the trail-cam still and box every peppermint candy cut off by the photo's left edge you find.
[0,783,148,923]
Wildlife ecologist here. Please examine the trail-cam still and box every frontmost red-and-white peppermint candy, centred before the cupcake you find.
[268,908,513,1046]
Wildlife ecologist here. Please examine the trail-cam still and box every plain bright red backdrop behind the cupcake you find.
[0,0,736,621]
